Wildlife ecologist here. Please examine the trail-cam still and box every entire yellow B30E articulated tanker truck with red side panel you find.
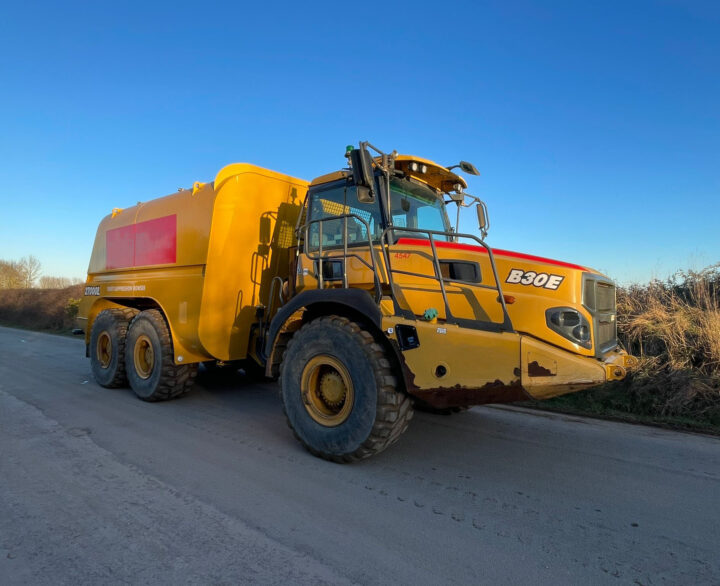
[80,143,635,462]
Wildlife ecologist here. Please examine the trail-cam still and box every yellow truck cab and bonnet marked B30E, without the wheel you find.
[268,144,634,416]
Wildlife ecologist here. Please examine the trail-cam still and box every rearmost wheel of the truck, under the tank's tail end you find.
[89,307,137,388]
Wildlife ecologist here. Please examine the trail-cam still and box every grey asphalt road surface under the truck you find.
[0,328,720,585]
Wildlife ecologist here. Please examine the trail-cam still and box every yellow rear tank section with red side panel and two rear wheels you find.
[79,164,307,400]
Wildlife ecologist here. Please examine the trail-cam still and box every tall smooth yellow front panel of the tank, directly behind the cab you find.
[199,164,308,360]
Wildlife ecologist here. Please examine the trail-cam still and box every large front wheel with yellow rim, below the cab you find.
[280,316,413,462]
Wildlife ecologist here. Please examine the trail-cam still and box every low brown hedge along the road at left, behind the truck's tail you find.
[0,285,83,333]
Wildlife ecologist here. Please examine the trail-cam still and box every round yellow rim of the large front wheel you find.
[300,354,355,427]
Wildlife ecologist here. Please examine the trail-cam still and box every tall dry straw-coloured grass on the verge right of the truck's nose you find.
[618,265,720,424]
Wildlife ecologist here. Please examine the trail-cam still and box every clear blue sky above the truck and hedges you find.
[0,0,720,283]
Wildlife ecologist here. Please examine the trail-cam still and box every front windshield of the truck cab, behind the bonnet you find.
[390,178,450,241]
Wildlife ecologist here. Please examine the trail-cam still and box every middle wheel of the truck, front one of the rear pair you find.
[125,309,197,401]
